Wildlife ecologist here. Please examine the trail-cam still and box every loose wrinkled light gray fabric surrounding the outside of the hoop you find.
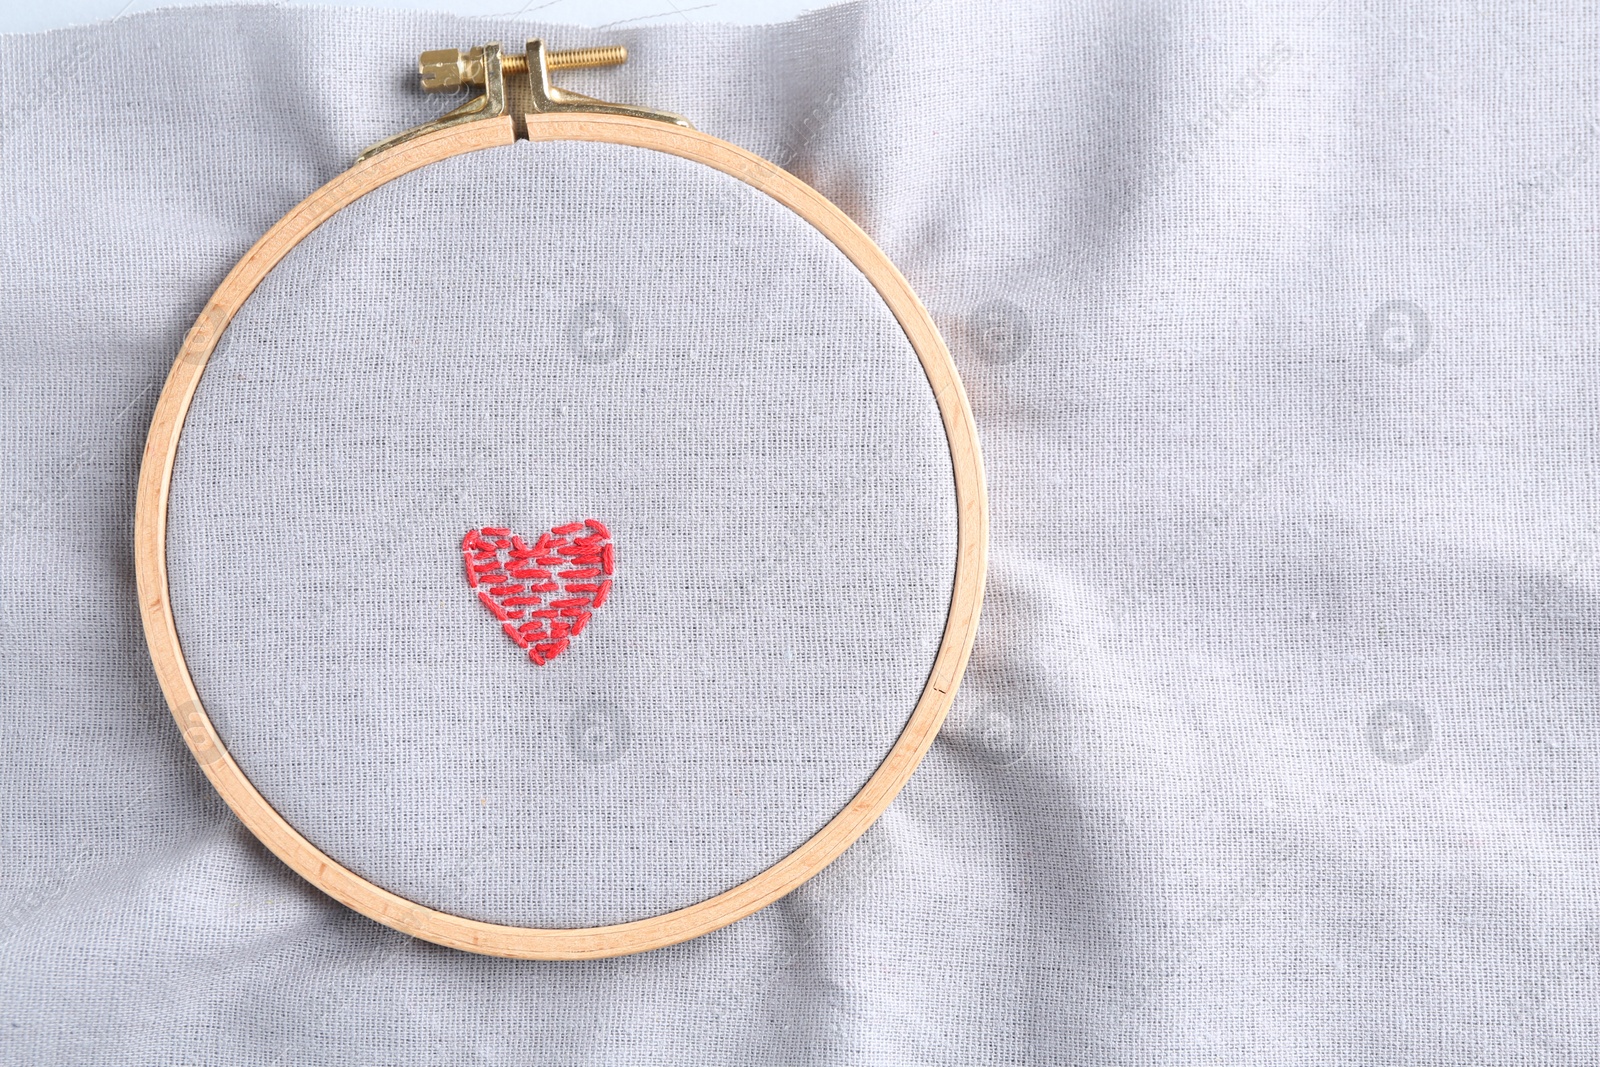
[0,0,1600,1065]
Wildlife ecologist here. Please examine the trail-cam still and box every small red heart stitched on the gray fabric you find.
[461,518,613,667]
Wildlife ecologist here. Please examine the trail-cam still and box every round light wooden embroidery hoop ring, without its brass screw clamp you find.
[134,114,989,960]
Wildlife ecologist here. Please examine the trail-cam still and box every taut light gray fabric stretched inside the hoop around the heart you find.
[168,142,955,926]
